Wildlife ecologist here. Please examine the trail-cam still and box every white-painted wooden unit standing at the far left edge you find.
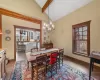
[0,50,6,80]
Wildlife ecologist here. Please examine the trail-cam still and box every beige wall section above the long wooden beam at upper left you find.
[0,0,48,20]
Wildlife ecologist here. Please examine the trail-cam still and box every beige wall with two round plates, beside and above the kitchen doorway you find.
[2,15,40,59]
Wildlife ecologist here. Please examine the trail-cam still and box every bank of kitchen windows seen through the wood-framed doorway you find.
[16,28,40,42]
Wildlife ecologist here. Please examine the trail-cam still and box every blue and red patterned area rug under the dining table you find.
[10,61,96,80]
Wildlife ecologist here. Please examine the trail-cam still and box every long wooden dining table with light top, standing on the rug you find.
[26,48,61,80]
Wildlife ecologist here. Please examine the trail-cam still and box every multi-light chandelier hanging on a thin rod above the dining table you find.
[43,2,55,32]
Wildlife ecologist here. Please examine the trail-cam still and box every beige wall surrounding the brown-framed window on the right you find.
[50,0,100,62]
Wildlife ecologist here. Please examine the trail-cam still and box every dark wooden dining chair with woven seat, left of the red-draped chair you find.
[34,54,47,80]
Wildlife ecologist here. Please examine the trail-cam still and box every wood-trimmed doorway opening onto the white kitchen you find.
[14,25,41,61]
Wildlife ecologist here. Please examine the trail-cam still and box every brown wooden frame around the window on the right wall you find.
[72,20,91,57]
